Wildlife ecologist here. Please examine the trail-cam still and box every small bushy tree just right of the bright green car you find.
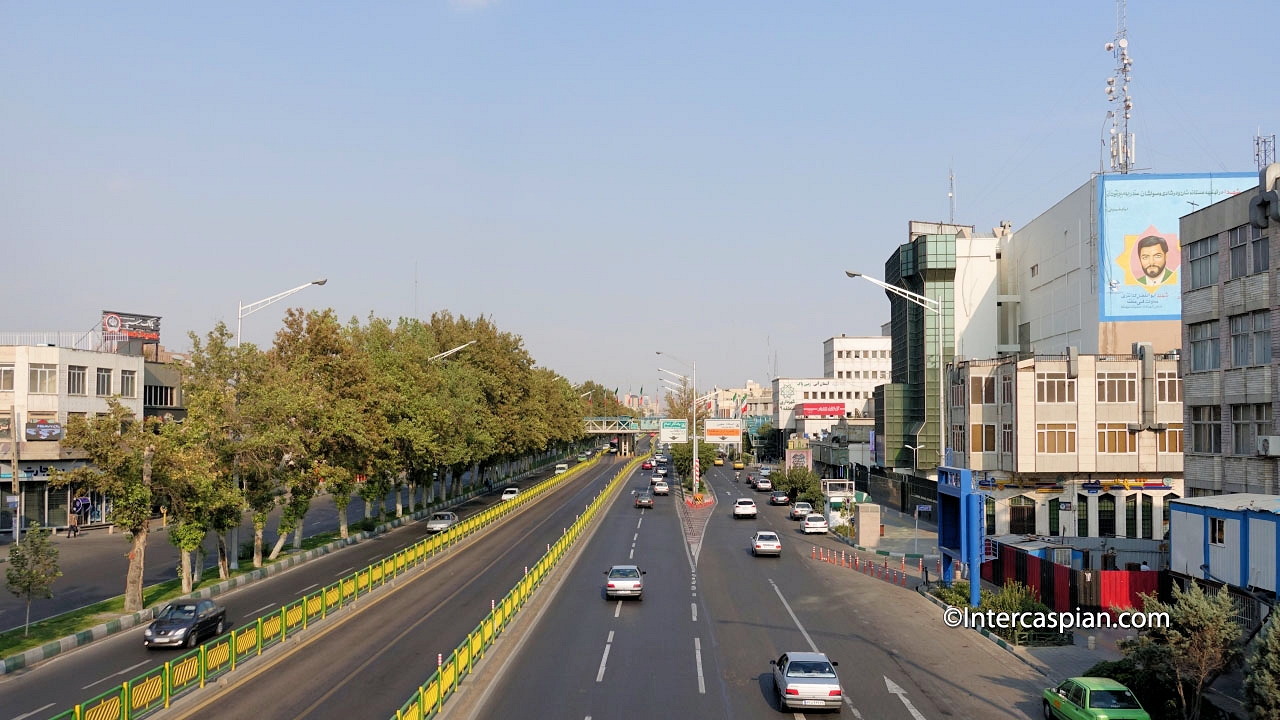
[1121,583,1243,720]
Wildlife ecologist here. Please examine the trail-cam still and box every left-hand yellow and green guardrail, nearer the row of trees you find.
[50,455,617,720]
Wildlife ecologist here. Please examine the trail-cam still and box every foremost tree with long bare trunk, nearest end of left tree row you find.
[50,398,170,612]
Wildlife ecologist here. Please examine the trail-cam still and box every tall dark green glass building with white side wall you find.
[873,220,1007,477]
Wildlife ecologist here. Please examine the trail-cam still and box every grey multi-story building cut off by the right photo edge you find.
[1179,164,1280,497]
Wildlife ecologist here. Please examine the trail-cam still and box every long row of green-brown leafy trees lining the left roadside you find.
[54,310,623,612]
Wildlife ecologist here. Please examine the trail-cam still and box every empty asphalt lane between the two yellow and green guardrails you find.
[160,457,623,720]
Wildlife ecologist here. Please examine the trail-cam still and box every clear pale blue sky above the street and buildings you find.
[0,0,1280,393]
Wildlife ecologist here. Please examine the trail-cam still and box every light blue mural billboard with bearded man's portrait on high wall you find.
[1098,173,1257,323]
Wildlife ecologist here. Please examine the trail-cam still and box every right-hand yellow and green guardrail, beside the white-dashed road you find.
[390,456,644,720]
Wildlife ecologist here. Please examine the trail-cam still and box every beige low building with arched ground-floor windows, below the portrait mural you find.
[947,345,1184,539]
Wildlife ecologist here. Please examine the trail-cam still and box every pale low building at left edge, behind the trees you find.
[0,345,146,532]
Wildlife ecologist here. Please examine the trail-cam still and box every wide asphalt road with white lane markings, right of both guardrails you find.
[475,468,1042,720]
